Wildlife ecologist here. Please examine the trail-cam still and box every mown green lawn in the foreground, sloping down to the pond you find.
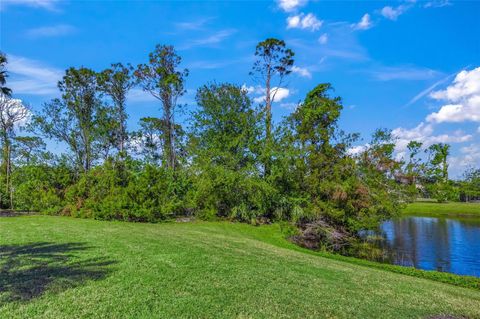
[0,216,480,318]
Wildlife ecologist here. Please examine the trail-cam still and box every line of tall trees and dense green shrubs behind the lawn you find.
[0,39,480,254]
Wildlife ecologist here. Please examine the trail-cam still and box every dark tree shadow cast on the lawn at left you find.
[0,242,115,305]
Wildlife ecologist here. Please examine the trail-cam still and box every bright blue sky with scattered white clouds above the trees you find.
[0,0,480,176]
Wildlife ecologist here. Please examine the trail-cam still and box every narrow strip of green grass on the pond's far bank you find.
[403,202,480,217]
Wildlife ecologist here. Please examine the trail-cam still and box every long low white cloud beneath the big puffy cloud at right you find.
[392,122,473,152]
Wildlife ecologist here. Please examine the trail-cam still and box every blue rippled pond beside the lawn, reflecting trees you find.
[381,217,480,277]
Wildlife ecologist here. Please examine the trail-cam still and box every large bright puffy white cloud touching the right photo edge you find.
[427,67,480,123]
